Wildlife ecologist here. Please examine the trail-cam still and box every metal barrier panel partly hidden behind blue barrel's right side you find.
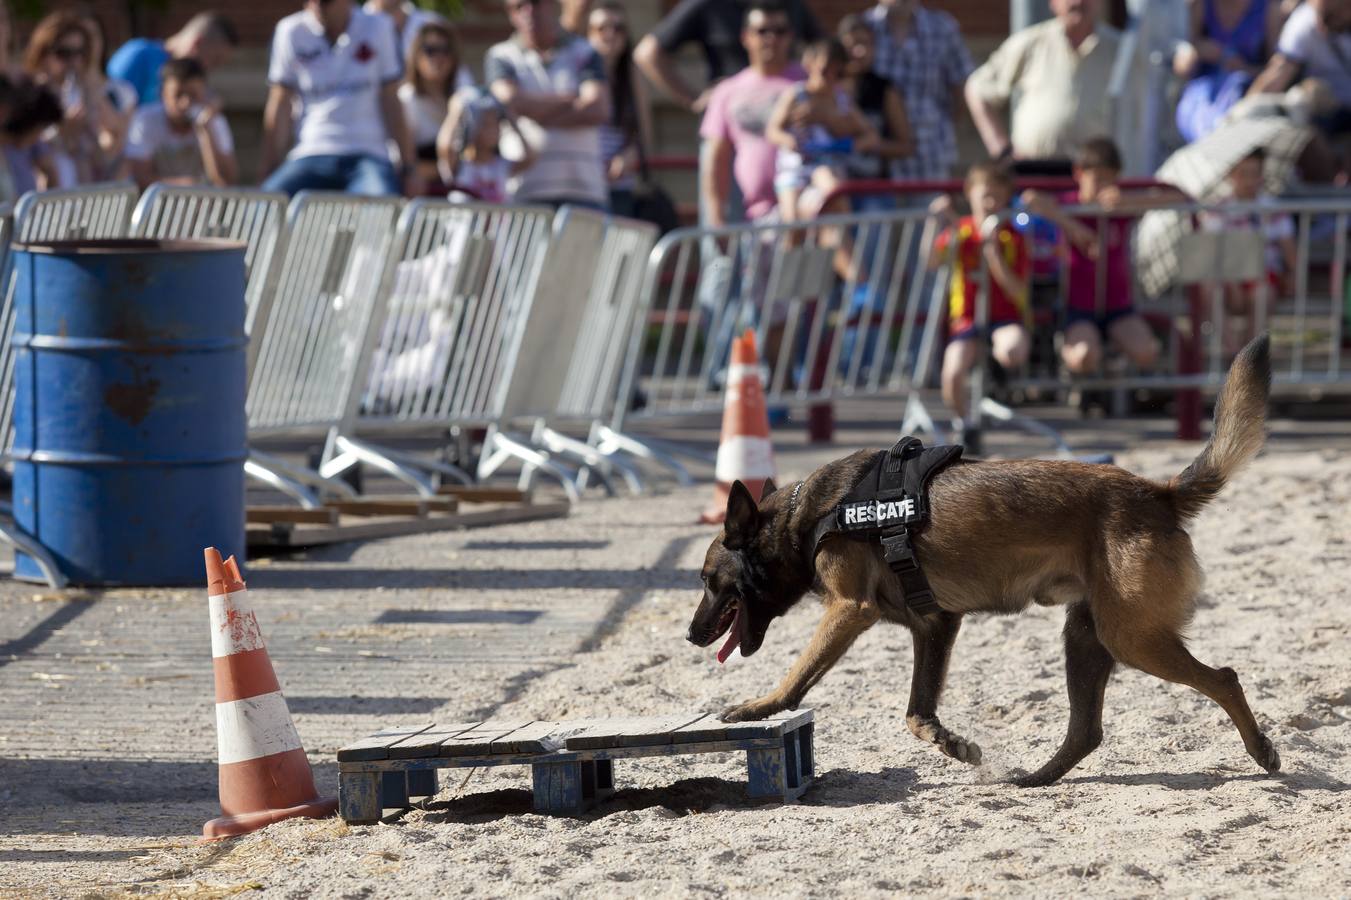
[131,184,286,334]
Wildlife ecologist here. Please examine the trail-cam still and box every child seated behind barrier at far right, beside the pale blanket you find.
[1200,147,1298,357]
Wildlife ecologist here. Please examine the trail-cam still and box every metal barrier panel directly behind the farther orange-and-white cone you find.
[612,209,946,421]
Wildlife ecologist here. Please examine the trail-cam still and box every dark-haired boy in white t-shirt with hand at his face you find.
[126,57,239,188]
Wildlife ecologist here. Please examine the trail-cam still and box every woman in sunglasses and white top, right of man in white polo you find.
[399,20,474,193]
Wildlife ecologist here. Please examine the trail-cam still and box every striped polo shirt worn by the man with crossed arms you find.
[484,32,609,205]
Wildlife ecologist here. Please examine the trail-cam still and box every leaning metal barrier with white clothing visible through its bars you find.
[320,200,562,497]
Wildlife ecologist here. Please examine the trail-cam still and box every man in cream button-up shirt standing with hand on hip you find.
[966,0,1121,168]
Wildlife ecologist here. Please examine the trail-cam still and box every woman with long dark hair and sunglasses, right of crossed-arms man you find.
[586,0,653,216]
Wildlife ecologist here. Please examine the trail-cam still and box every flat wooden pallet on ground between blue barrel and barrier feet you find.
[246,497,569,551]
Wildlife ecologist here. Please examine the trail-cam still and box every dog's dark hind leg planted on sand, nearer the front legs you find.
[1015,600,1115,788]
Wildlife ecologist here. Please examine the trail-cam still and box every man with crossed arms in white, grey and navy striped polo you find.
[484,0,609,209]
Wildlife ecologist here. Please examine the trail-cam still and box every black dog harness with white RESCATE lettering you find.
[790,438,962,615]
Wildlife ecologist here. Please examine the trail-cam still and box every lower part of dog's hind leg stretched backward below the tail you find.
[1108,632,1281,773]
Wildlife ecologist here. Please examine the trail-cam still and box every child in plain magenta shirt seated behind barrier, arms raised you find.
[1023,138,1173,374]
